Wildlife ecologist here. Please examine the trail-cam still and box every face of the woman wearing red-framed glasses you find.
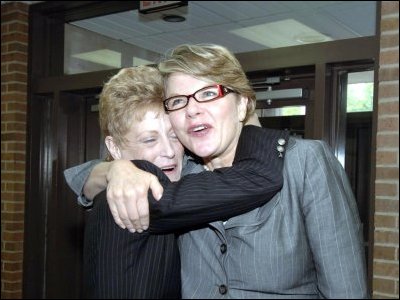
[166,73,247,165]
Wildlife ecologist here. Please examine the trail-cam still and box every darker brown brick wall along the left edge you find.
[1,2,28,299]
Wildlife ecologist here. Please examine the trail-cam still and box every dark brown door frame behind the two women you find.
[23,1,380,298]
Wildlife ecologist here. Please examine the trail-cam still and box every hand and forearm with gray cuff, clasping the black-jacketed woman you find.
[64,159,162,228]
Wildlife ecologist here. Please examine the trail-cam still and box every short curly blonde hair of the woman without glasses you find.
[99,66,164,159]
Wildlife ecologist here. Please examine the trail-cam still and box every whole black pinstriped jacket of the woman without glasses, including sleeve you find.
[84,126,288,299]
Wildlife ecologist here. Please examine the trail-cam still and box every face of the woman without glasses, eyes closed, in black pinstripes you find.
[116,111,184,181]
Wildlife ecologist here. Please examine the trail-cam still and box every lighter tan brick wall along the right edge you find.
[373,1,399,299]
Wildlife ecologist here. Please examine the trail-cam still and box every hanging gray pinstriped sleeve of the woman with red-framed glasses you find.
[303,141,367,299]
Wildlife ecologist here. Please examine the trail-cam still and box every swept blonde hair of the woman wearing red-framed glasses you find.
[158,44,256,122]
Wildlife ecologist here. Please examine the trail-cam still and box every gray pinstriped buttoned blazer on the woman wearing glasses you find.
[179,138,367,299]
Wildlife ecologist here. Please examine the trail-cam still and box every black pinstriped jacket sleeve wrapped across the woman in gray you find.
[133,126,289,233]
